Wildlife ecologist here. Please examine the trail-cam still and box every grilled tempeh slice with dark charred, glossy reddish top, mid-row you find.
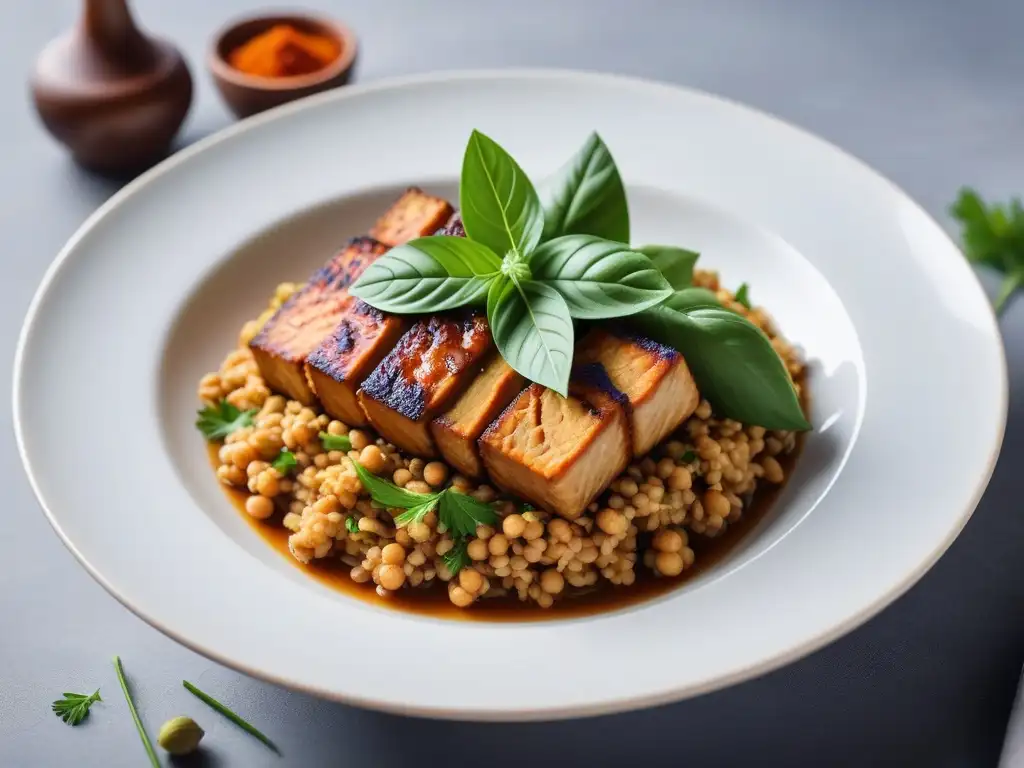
[359,311,494,457]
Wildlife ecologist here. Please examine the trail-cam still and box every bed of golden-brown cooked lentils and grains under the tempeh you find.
[199,270,804,608]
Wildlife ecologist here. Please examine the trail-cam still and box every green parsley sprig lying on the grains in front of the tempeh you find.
[349,462,498,575]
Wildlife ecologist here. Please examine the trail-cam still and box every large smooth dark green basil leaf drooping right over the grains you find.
[633,306,810,429]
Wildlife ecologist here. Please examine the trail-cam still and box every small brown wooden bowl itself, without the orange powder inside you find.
[208,13,358,118]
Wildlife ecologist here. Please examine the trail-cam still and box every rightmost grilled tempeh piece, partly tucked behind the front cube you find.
[575,329,700,456]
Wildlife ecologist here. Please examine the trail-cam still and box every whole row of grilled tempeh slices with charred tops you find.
[245,188,699,519]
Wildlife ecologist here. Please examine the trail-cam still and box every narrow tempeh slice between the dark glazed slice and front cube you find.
[430,352,526,477]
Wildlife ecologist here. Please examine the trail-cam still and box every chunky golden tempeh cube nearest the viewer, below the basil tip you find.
[479,364,632,520]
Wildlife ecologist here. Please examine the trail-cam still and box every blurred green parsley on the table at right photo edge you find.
[949,187,1024,312]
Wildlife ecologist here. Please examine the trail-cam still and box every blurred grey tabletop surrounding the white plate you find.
[0,0,1024,768]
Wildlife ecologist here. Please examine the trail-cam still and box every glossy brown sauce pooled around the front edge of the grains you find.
[209,442,804,622]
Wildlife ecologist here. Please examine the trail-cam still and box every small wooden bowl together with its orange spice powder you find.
[208,13,357,118]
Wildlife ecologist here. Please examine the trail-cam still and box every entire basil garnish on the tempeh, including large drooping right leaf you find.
[351,131,810,429]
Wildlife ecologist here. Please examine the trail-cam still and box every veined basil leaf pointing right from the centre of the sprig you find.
[529,234,672,319]
